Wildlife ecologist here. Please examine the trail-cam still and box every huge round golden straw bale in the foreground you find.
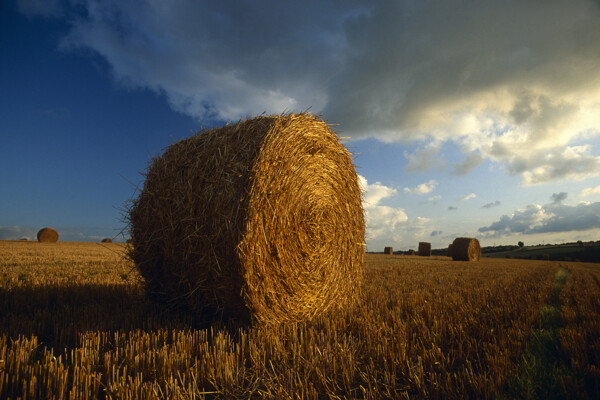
[129,113,365,323]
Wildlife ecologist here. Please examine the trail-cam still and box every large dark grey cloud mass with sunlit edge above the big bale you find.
[19,0,600,185]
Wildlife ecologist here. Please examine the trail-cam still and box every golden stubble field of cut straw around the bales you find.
[0,241,600,399]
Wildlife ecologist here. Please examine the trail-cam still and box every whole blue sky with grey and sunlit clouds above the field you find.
[0,0,600,251]
